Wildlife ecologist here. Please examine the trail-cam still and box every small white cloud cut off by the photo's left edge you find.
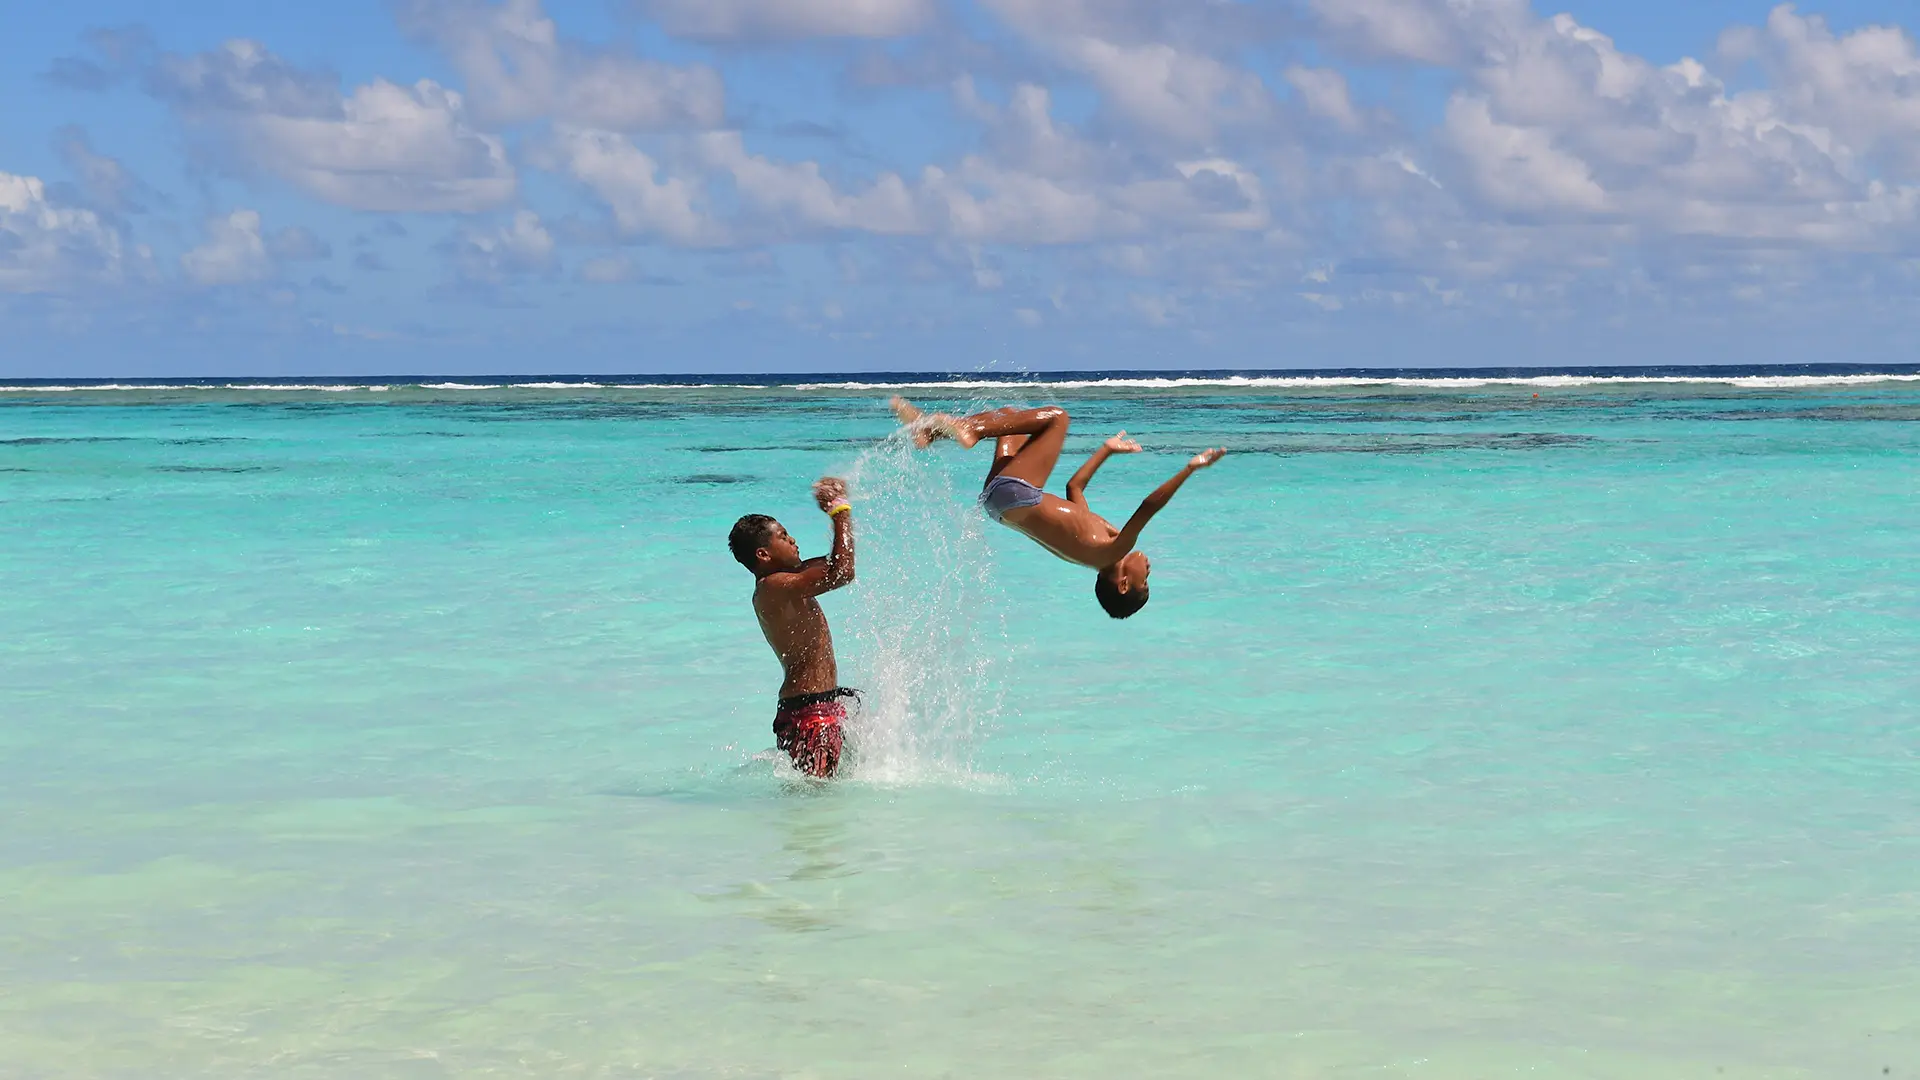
[0,173,150,292]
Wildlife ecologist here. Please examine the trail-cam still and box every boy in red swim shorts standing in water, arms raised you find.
[726,477,858,780]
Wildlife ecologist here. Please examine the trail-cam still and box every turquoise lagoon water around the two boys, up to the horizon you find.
[0,379,1920,1078]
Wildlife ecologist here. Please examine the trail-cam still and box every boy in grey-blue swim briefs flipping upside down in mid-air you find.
[891,398,1227,619]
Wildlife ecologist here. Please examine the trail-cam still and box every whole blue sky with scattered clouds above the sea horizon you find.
[0,0,1920,377]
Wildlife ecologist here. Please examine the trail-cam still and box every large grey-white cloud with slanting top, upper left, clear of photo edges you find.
[152,40,516,213]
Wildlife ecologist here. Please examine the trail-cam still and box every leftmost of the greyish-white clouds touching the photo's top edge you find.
[403,0,726,131]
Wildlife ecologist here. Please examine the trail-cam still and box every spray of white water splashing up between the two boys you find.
[841,424,1010,784]
